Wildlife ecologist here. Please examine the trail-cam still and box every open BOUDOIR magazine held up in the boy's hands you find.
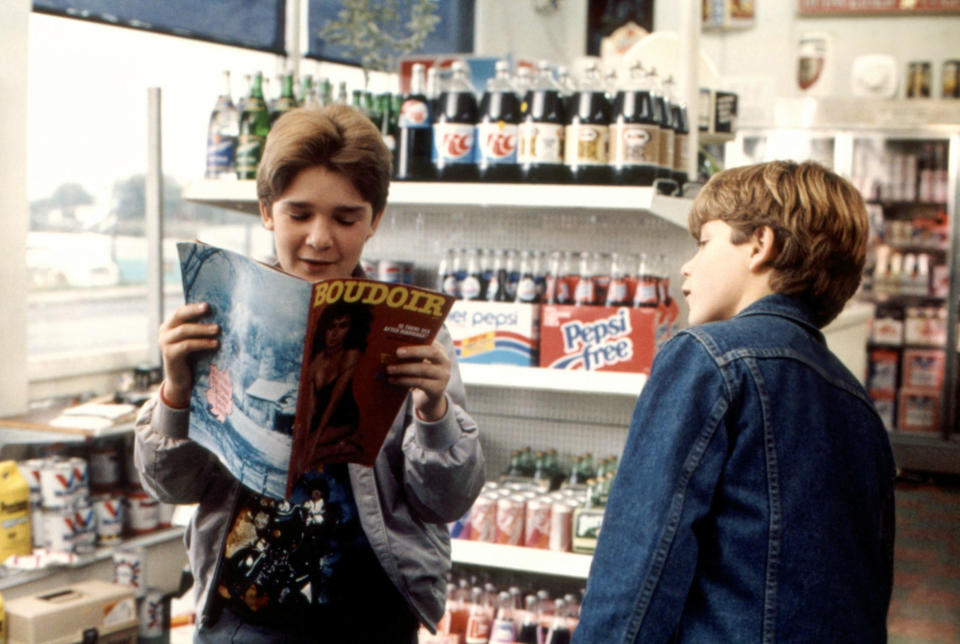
[177,242,453,499]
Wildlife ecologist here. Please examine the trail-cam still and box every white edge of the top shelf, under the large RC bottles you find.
[184,180,692,228]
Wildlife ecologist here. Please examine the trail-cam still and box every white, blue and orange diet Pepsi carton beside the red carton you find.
[446,300,540,367]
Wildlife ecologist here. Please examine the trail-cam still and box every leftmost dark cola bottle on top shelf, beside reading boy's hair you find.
[395,63,433,181]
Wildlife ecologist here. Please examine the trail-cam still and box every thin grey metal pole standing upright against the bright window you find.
[144,87,163,364]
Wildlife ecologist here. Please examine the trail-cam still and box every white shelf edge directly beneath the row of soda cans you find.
[450,539,593,579]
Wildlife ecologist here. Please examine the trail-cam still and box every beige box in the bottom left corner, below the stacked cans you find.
[7,580,139,644]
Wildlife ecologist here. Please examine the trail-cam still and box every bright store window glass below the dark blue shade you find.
[27,11,283,378]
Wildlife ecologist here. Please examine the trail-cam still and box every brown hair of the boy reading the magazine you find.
[257,105,392,219]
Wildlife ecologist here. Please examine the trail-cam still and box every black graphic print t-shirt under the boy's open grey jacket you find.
[217,464,403,625]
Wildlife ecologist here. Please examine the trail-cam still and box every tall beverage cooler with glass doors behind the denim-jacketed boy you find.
[726,99,960,474]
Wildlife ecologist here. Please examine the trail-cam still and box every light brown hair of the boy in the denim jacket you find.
[689,161,868,327]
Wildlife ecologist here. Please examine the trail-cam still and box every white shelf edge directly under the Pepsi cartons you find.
[460,362,647,398]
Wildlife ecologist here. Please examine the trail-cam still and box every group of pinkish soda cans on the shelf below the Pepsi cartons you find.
[451,482,585,552]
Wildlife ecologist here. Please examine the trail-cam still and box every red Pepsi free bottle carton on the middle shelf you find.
[540,304,669,374]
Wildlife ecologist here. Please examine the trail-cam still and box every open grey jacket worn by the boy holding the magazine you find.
[134,329,485,631]
